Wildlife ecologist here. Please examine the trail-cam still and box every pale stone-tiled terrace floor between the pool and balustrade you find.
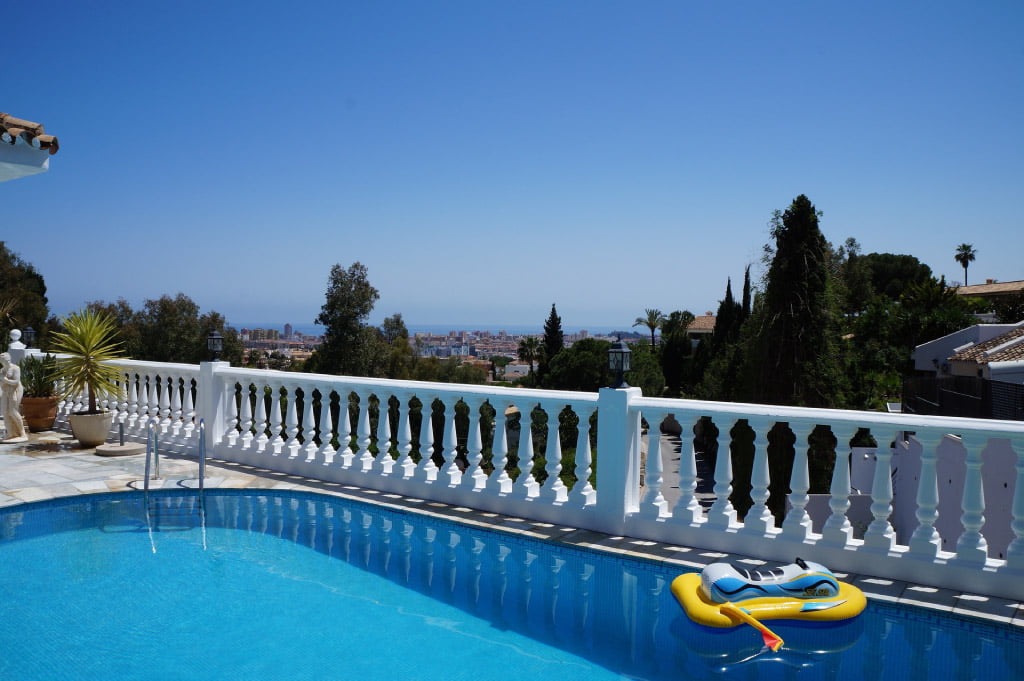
[6,433,1024,627]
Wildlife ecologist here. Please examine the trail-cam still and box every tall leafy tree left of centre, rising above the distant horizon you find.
[311,262,380,376]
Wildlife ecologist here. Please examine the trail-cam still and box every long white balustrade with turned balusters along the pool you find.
[49,360,1024,598]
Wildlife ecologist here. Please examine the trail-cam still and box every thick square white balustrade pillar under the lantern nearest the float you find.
[595,388,643,535]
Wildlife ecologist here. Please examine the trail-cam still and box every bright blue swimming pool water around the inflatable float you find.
[0,491,1024,681]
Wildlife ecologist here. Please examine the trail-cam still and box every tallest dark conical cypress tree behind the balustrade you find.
[744,195,843,407]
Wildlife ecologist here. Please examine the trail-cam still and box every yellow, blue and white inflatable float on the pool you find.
[672,558,867,649]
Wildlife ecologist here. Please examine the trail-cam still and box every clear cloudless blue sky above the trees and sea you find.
[0,0,1024,329]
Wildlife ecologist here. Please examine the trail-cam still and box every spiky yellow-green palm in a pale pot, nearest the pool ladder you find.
[51,309,124,446]
